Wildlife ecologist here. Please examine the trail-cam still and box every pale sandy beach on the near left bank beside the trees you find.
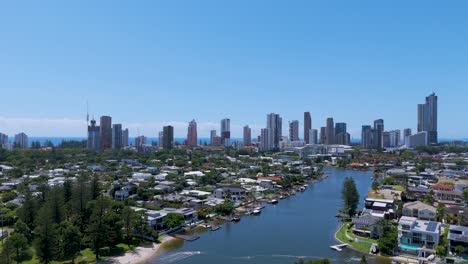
[100,236,176,264]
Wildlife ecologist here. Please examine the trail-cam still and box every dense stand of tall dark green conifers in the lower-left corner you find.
[0,172,157,264]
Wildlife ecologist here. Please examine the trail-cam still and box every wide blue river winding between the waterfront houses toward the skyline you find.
[151,168,390,264]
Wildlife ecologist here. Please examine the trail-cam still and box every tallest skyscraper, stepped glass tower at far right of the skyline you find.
[418,93,438,144]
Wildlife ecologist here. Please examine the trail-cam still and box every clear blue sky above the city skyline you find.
[0,0,468,138]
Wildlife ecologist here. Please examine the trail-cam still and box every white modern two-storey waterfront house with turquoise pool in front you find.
[398,216,442,257]
